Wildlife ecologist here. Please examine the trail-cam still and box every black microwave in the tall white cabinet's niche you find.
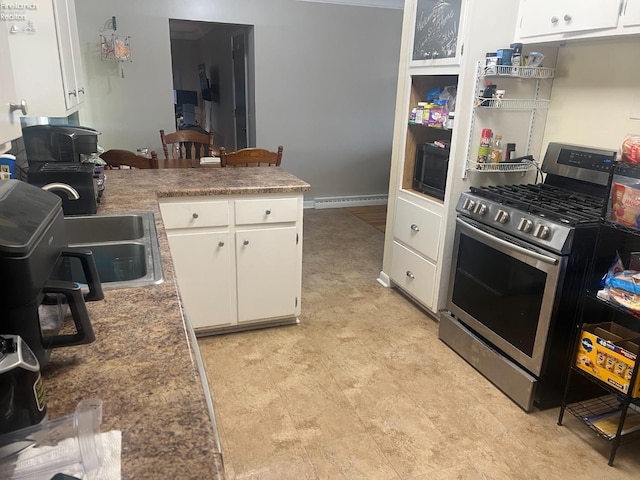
[413,143,449,200]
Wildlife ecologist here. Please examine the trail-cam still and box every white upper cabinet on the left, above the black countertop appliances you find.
[6,0,85,117]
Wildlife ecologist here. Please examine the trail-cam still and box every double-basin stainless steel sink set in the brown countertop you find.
[57,212,163,290]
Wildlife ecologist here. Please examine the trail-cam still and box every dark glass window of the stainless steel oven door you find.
[452,234,546,357]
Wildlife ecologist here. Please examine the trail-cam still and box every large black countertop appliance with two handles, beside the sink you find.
[0,180,104,368]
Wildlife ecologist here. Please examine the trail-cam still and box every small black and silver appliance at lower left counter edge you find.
[0,335,47,435]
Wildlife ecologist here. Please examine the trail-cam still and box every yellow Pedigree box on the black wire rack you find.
[576,322,640,397]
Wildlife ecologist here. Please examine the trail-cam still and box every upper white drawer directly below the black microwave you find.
[393,198,442,262]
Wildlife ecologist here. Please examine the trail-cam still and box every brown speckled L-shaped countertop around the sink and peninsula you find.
[42,167,310,479]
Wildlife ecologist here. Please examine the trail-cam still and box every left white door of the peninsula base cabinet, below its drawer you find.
[167,231,235,330]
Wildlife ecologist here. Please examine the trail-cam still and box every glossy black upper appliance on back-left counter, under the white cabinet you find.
[22,125,100,166]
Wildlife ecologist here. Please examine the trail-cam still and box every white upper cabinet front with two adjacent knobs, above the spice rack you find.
[519,0,620,38]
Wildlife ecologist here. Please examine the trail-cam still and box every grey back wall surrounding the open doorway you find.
[76,0,402,198]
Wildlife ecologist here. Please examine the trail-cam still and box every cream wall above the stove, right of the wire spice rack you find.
[543,38,640,150]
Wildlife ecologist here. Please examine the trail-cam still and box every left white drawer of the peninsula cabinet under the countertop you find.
[160,200,229,230]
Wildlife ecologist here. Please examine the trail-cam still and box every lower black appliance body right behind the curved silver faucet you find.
[27,162,101,215]
